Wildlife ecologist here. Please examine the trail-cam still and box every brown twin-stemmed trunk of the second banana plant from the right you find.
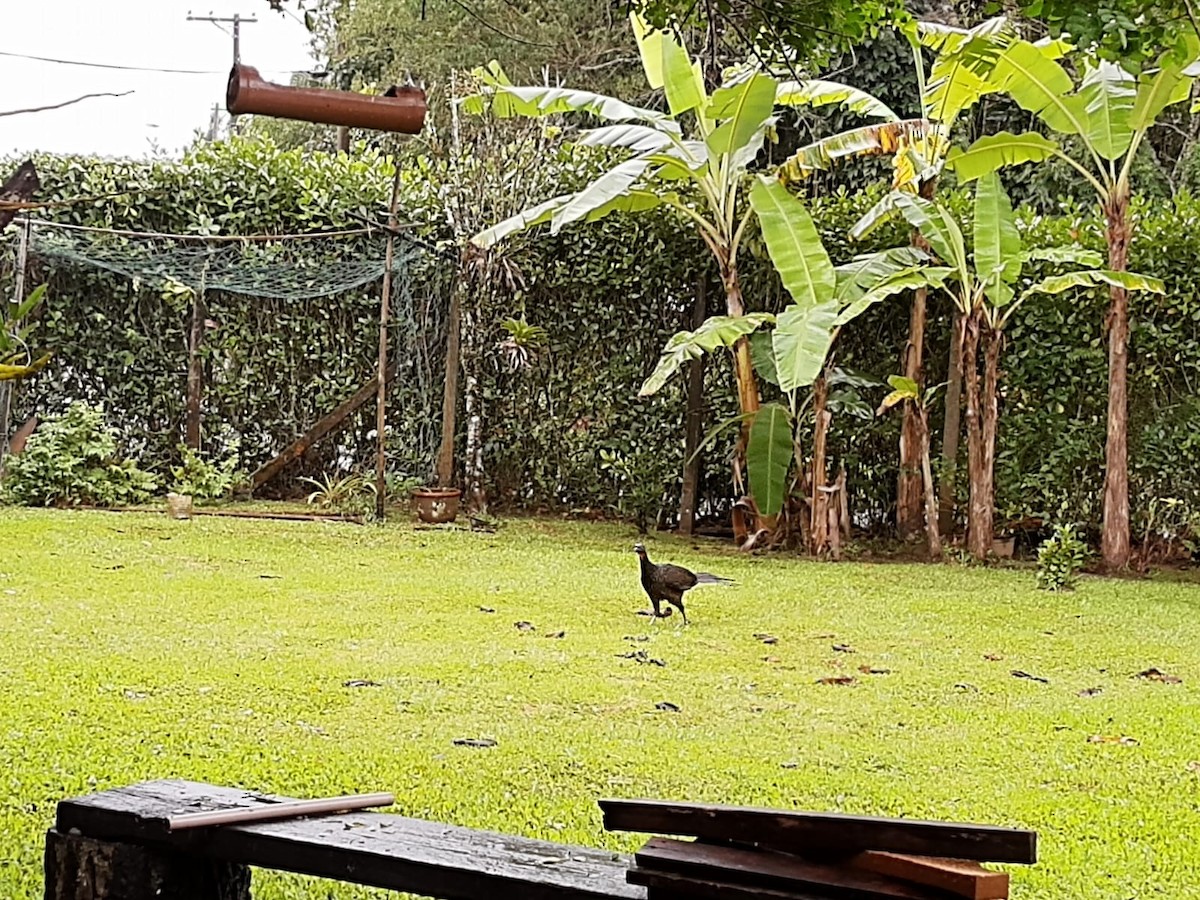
[962,313,1000,560]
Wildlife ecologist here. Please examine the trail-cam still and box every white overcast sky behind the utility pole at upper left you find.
[0,0,316,157]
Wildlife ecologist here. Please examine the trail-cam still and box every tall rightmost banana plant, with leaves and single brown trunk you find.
[947,41,1200,569]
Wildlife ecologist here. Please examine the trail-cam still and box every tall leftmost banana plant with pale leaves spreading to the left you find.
[462,14,926,528]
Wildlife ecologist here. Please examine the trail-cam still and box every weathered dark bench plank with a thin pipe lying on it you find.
[56,781,646,900]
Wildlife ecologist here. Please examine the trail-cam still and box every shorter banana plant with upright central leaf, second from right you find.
[896,172,1163,559]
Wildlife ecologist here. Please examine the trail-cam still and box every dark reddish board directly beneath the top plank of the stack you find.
[634,838,944,900]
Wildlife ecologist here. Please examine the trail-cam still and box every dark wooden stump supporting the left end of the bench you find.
[44,828,250,900]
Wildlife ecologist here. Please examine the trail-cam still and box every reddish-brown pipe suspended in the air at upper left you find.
[226,65,426,134]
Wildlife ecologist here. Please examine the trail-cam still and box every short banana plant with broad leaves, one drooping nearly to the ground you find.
[641,175,949,552]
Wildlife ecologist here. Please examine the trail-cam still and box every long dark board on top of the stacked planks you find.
[600,800,1037,863]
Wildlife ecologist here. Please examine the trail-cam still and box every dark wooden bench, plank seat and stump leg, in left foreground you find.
[46,781,647,900]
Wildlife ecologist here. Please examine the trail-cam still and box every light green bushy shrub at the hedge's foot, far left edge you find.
[2,401,158,506]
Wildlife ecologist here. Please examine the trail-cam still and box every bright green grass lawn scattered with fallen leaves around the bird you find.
[0,510,1200,900]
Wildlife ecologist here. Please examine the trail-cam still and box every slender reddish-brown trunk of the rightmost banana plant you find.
[1100,192,1132,570]
